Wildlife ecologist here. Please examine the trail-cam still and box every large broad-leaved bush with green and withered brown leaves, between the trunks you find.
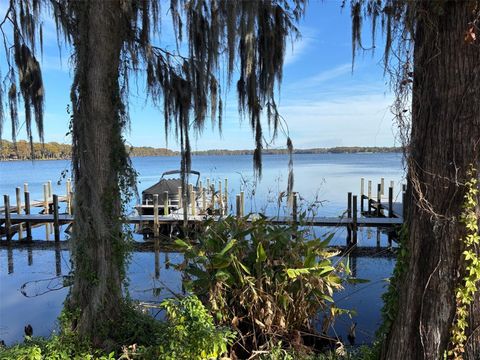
[176,217,342,350]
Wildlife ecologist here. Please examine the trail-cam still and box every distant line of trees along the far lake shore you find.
[0,140,402,161]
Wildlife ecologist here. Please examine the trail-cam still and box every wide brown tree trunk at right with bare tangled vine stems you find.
[382,1,480,360]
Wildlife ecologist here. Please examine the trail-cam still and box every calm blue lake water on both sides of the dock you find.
[0,153,404,344]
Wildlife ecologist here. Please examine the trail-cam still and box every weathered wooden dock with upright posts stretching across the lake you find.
[0,178,405,245]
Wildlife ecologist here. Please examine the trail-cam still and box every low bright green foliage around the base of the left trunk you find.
[0,296,235,360]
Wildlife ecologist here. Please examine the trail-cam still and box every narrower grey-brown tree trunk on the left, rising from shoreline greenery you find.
[67,0,126,346]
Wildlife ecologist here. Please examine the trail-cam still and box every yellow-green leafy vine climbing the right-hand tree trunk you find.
[448,166,480,359]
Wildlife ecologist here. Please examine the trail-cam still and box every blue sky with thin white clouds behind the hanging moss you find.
[0,0,396,150]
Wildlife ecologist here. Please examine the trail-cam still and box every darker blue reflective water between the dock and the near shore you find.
[0,241,394,344]
